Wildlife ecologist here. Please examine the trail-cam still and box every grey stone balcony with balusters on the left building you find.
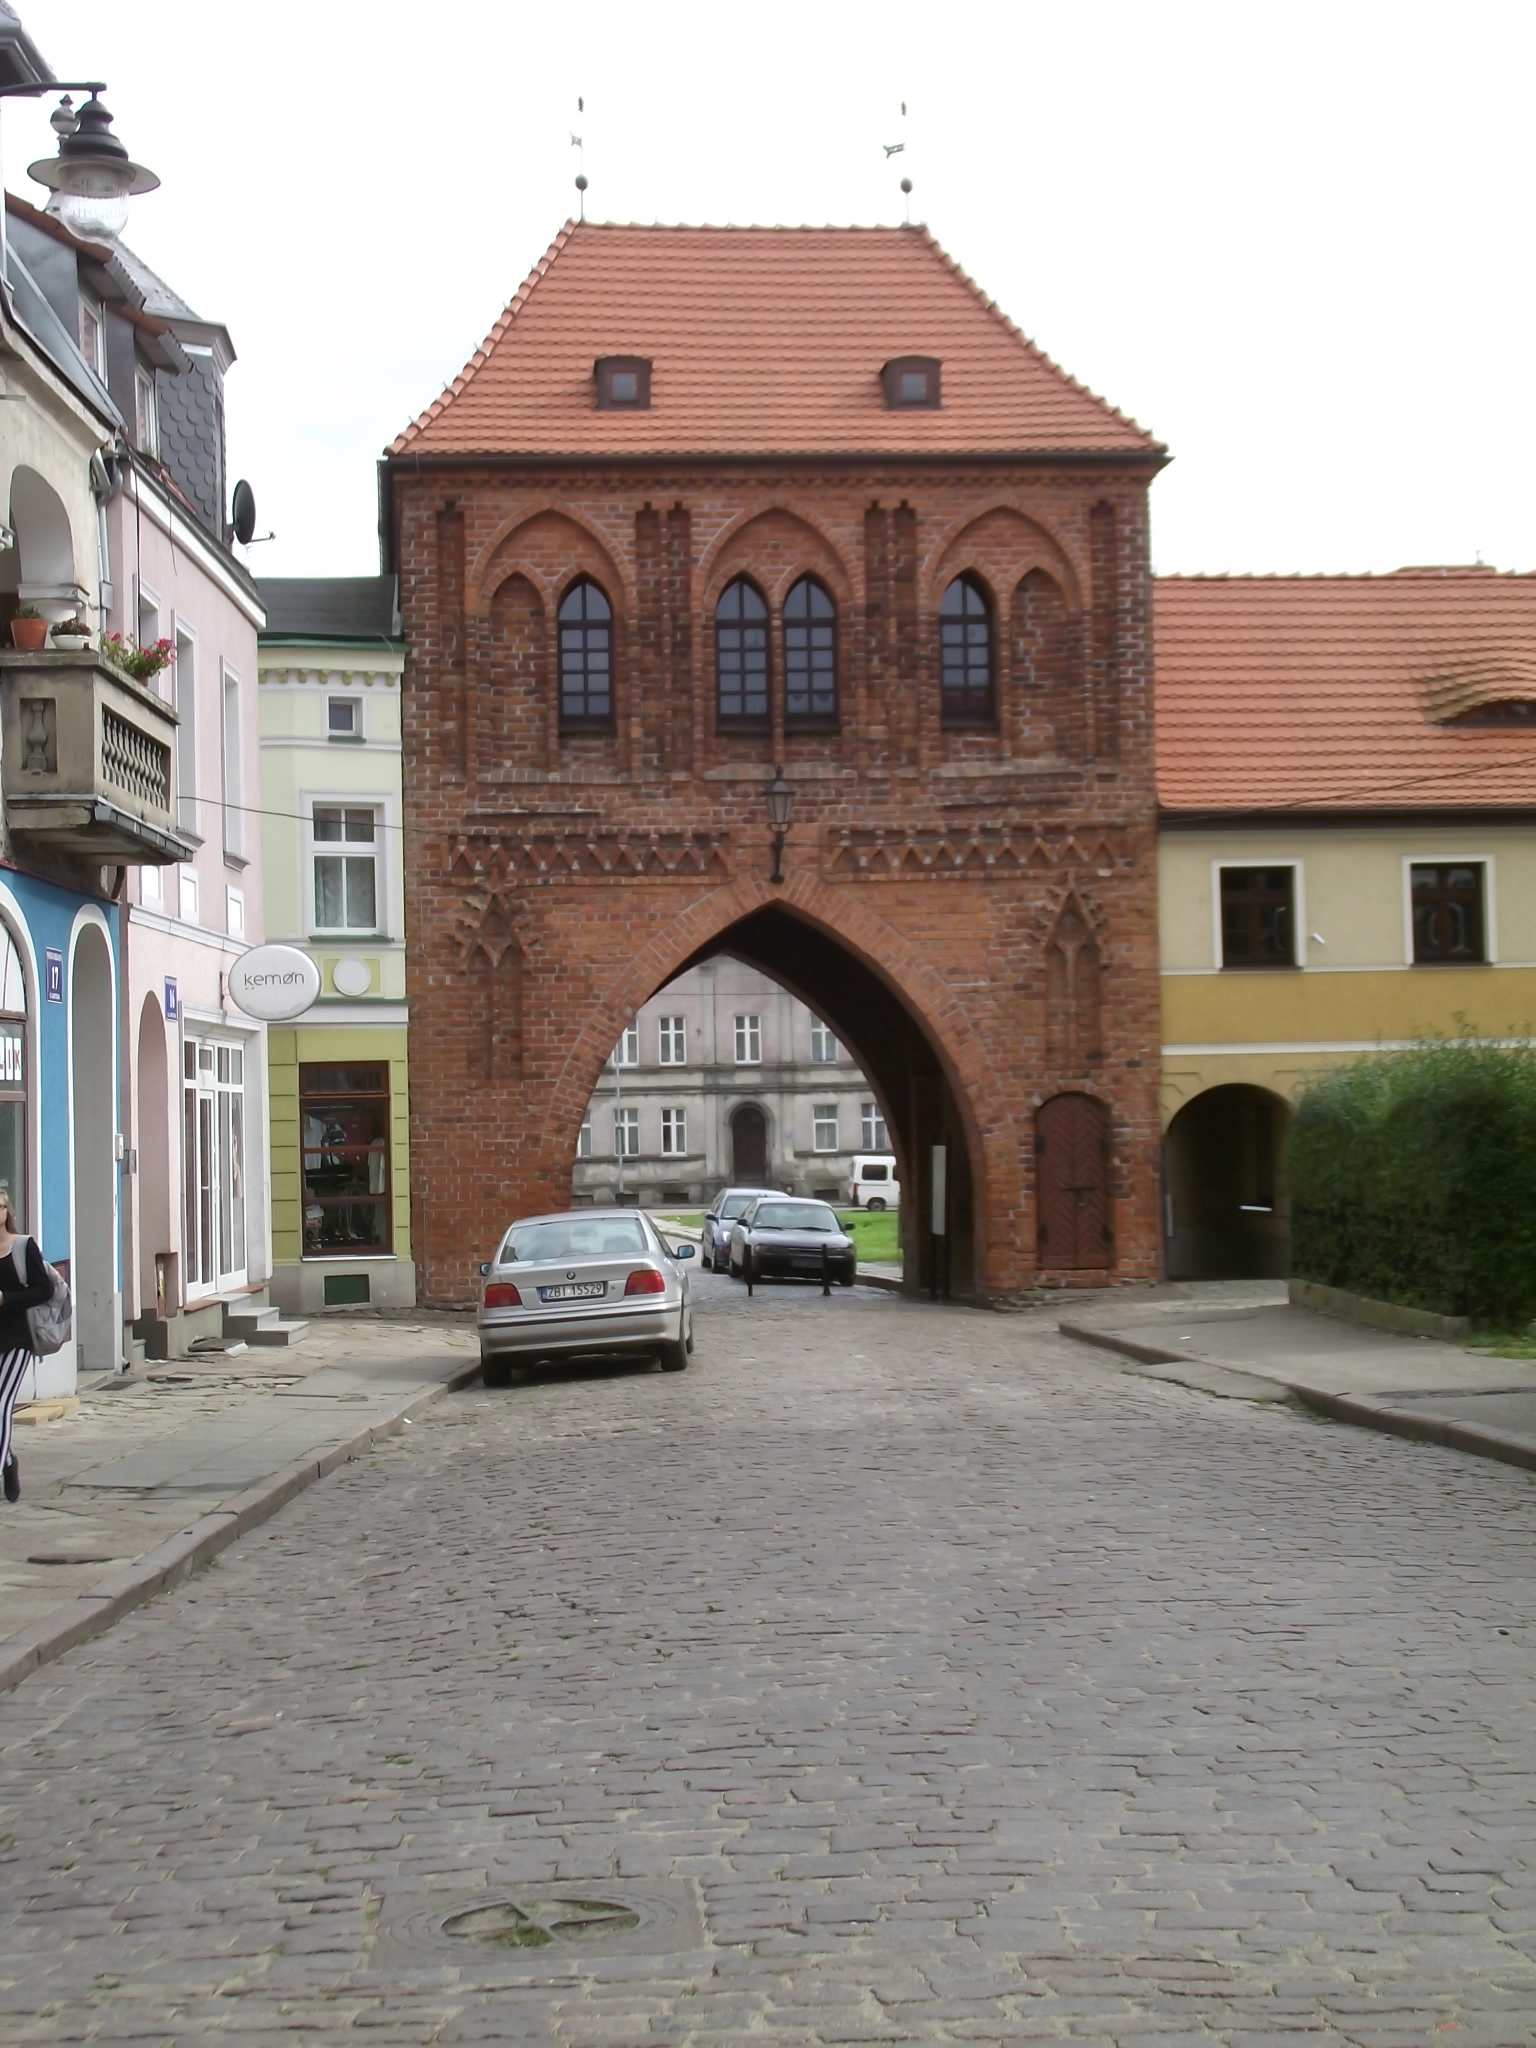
[0,651,193,868]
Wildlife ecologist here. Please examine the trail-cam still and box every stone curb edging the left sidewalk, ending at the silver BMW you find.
[0,1358,479,1692]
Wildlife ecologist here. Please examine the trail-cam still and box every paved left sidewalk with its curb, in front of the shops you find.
[0,1313,479,1692]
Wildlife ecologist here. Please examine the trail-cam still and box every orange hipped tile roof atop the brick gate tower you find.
[389,221,1163,457]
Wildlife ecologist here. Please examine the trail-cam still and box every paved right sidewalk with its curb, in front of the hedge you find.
[1057,1280,1536,1470]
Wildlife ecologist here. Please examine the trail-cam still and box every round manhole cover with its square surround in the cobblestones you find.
[373,1878,709,1976]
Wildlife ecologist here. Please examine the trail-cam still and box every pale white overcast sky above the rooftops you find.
[0,0,1536,575]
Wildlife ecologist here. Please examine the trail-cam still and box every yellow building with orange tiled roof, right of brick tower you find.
[1157,569,1536,1280]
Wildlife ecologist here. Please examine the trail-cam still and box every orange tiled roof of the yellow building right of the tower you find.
[1153,567,1536,815]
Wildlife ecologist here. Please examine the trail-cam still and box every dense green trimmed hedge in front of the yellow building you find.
[1288,1036,1536,1329]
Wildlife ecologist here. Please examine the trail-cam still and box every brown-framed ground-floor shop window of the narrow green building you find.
[299,1065,393,1260]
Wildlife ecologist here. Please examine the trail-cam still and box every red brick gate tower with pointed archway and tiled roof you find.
[383,223,1165,1303]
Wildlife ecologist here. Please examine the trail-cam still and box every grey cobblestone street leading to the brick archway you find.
[0,1278,1536,2048]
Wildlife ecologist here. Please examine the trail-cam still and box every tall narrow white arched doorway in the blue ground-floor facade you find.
[70,924,121,1372]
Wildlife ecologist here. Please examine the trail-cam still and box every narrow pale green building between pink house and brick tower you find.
[258,578,416,1315]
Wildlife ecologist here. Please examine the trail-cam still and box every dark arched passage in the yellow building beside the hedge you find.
[1165,1083,1290,1280]
